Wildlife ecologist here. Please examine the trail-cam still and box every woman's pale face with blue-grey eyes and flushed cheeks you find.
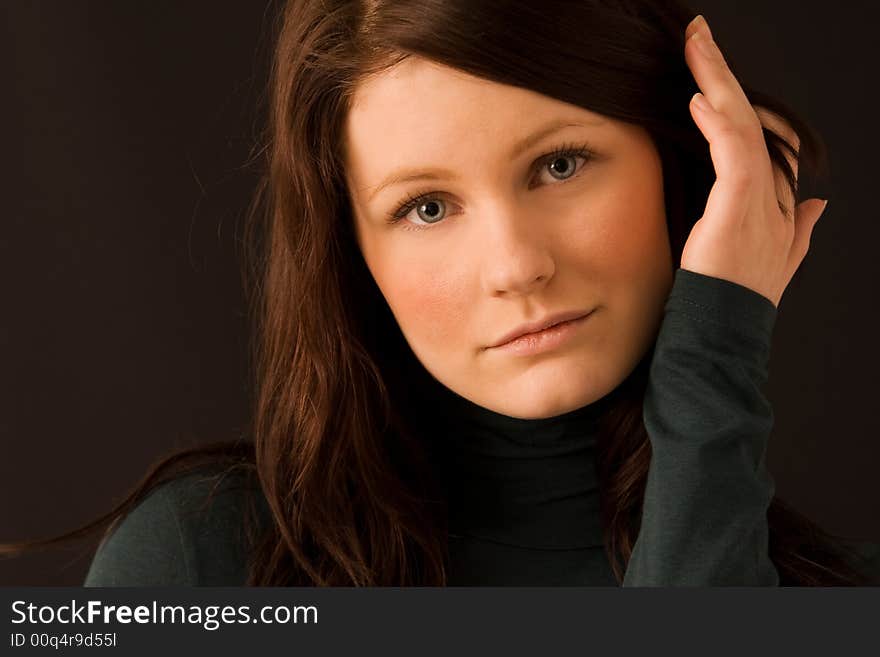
[345,57,674,418]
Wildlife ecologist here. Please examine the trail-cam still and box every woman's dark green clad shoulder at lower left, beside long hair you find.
[84,467,268,586]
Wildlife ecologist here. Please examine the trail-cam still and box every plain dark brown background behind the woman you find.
[0,0,880,585]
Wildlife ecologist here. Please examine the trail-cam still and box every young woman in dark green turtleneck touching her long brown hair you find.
[5,0,880,586]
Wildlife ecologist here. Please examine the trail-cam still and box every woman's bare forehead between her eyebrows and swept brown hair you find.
[345,57,603,186]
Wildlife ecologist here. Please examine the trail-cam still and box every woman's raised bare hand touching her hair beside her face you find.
[681,16,827,307]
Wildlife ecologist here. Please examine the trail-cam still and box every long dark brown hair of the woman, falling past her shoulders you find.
[2,0,869,586]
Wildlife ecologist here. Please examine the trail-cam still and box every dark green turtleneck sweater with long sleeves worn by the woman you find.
[85,269,880,586]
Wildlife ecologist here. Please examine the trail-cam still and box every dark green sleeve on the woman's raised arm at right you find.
[623,269,779,587]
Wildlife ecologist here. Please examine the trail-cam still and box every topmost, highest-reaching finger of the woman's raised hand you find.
[685,16,760,137]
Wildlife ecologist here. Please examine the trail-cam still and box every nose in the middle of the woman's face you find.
[478,207,555,296]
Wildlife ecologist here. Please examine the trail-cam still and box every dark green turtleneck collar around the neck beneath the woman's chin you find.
[429,381,613,549]
